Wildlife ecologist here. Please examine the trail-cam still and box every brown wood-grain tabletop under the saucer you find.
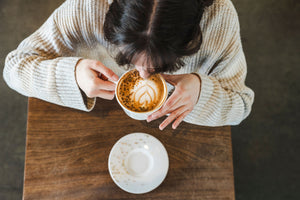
[23,98,234,200]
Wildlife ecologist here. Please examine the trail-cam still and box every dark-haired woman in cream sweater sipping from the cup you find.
[4,0,254,130]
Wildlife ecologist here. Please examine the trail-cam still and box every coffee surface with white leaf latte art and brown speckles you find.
[119,70,164,112]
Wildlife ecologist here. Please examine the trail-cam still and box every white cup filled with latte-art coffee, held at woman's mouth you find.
[116,69,168,120]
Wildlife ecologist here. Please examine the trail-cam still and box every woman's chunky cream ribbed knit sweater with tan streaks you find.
[3,0,254,126]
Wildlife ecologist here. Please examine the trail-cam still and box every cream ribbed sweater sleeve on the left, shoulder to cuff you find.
[3,0,108,111]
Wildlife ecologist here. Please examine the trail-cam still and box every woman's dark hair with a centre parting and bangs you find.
[104,0,213,73]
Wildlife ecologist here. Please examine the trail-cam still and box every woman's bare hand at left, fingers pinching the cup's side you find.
[75,59,119,100]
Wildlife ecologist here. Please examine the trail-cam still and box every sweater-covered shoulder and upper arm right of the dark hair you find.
[191,0,240,72]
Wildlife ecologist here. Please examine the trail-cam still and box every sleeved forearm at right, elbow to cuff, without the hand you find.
[185,50,254,126]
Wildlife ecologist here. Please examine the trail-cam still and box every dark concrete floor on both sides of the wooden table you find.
[0,0,300,200]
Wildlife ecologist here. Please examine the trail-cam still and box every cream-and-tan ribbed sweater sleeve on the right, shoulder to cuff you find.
[185,0,254,126]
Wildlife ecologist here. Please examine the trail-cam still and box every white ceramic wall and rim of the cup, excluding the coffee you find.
[115,71,168,120]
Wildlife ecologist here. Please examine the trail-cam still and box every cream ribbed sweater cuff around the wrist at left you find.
[55,57,96,111]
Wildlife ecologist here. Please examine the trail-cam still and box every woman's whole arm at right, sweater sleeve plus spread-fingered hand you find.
[148,1,254,129]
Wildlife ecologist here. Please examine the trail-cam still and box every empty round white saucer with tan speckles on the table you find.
[108,133,169,194]
